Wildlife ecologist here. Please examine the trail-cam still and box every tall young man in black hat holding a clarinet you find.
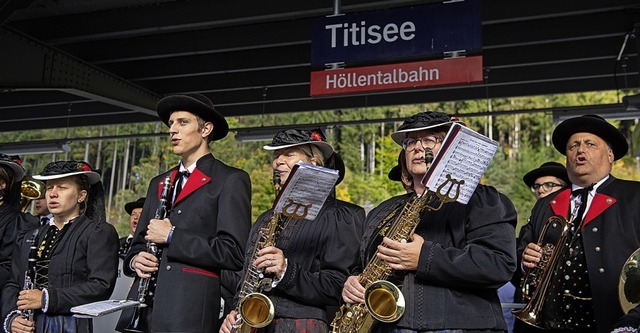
[118,94,251,332]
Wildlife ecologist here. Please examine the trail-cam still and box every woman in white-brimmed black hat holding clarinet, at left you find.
[2,161,118,332]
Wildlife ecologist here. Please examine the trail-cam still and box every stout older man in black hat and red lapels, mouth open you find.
[518,115,640,333]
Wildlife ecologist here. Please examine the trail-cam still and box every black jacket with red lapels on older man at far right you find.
[516,176,640,333]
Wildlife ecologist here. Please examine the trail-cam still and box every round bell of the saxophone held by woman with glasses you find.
[364,280,405,323]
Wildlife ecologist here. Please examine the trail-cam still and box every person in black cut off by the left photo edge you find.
[0,154,24,296]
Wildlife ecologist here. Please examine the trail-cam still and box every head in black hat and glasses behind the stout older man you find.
[522,162,570,199]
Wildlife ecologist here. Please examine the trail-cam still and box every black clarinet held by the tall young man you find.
[124,174,171,333]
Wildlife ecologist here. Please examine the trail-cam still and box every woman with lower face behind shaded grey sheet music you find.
[220,130,360,333]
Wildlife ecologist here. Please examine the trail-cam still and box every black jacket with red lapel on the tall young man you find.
[123,154,251,332]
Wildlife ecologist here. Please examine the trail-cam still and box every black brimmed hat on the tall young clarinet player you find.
[156,94,229,141]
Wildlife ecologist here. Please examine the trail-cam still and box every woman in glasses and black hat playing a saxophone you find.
[340,112,516,333]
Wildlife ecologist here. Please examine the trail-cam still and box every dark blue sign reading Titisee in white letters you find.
[311,0,482,68]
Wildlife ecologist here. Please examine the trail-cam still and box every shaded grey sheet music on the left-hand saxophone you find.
[274,162,338,220]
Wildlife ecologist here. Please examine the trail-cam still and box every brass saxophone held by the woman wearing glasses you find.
[331,162,464,333]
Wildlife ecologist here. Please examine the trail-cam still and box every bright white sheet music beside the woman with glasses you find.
[422,123,498,204]
